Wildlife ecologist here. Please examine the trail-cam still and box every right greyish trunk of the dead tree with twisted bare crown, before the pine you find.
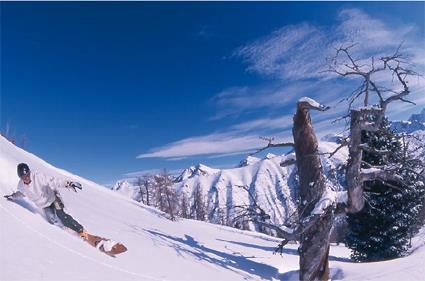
[328,45,420,213]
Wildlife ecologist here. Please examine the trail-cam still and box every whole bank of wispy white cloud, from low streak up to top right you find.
[138,9,425,159]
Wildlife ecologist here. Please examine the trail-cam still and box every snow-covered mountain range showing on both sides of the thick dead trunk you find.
[175,138,347,231]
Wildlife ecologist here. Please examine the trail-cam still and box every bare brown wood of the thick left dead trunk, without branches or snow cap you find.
[292,102,333,281]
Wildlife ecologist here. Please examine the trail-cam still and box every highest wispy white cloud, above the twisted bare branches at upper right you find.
[234,9,423,81]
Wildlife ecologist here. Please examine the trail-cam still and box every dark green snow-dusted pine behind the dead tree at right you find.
[346,118,424,261]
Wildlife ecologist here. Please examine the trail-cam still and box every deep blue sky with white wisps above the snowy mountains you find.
[0,2,425,184]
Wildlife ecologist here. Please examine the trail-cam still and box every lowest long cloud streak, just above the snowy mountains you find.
[137,112,350,159]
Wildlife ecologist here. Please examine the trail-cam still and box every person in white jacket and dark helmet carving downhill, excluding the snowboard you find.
[4,163,87,239]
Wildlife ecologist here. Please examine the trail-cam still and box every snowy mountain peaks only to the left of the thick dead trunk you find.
[175,151,296,234]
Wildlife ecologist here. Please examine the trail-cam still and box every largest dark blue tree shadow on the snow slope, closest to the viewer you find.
[145,230,278,280]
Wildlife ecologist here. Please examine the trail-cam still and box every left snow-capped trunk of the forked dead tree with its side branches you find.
[245,98,338,280]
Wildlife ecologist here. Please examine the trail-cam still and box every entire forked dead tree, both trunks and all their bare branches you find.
[238,43,419,280]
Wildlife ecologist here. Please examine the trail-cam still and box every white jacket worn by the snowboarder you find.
[18,171,67,208]
